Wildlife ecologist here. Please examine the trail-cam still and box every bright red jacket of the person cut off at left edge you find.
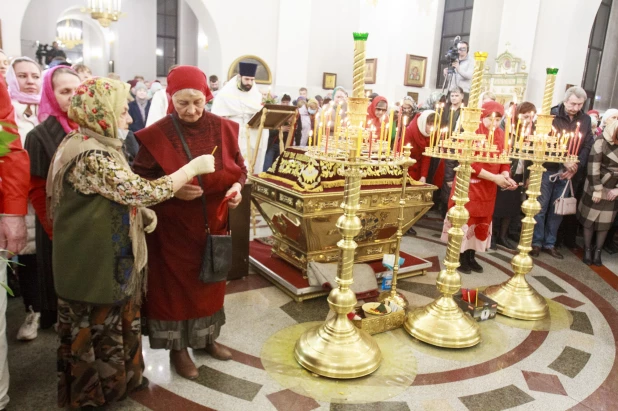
[0,75,30,215]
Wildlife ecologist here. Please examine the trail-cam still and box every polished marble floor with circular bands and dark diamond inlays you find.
[7,214,618,411]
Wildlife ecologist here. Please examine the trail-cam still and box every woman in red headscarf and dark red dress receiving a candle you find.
[133,66,247,379]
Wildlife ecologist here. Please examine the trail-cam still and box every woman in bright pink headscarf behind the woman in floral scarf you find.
[18,66,80,340]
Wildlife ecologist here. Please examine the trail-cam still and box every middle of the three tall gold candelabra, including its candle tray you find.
[404,52,510,348]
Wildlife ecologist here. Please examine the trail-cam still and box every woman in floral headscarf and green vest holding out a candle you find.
[47,78,215,408]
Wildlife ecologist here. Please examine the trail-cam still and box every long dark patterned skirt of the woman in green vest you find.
[58,299,144,408]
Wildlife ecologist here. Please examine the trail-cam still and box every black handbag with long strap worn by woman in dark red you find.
[170,114,232,284]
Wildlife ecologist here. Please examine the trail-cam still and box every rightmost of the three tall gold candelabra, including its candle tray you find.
[485,68,581,320]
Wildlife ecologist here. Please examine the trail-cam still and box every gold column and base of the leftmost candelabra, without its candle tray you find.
[294,33,382,379]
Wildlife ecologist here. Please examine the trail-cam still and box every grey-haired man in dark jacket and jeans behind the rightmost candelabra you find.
[530,87,594,259]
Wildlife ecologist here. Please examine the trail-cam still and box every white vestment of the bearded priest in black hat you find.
[211,79,268,173]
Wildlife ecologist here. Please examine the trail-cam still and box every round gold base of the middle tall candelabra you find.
[403,296,481,348]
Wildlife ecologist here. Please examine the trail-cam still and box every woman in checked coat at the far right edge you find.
[577,121,618,266]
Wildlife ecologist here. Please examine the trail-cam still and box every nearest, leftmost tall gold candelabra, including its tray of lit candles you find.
[294,33,414,379]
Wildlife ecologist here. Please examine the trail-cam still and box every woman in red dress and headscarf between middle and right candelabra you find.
[442,101,517,274]
